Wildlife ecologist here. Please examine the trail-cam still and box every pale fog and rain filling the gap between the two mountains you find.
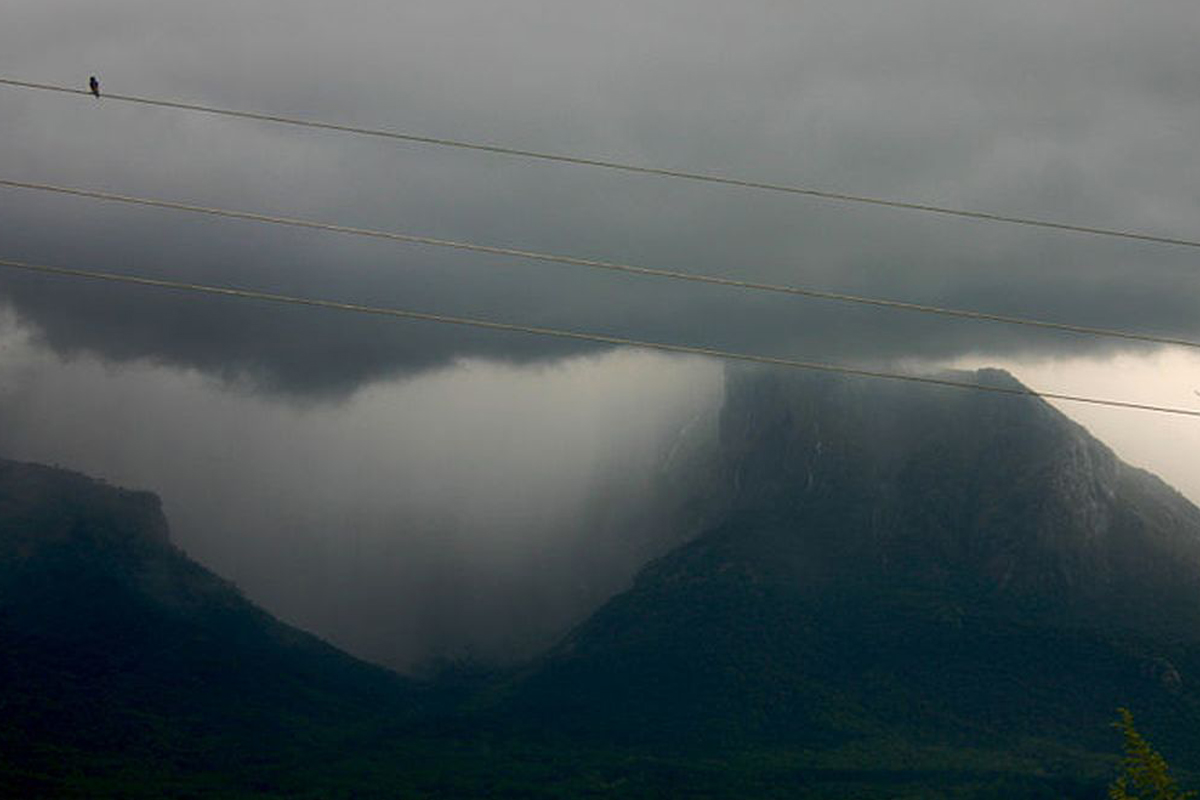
[0,316,722,669]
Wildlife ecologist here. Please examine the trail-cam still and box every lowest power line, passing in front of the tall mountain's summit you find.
[0,259,1200,417]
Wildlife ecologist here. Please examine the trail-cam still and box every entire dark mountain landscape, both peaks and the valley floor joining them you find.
[0,368,1200,799]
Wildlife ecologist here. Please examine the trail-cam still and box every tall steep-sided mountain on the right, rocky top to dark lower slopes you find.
[494,369,1200,786]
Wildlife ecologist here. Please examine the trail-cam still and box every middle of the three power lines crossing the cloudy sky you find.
[0,178,1200,349]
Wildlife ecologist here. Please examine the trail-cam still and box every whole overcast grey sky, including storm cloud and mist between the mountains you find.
[0,0,1200,664]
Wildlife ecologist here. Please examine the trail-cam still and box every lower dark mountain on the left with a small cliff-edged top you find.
[0,461,426,796]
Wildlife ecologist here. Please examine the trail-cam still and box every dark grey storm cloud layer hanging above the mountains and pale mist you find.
[0,0,1200,395]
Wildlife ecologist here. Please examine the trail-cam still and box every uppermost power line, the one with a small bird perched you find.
[0,78,1200,247]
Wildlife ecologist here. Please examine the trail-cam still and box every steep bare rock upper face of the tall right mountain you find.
[705,369,1200,636]
